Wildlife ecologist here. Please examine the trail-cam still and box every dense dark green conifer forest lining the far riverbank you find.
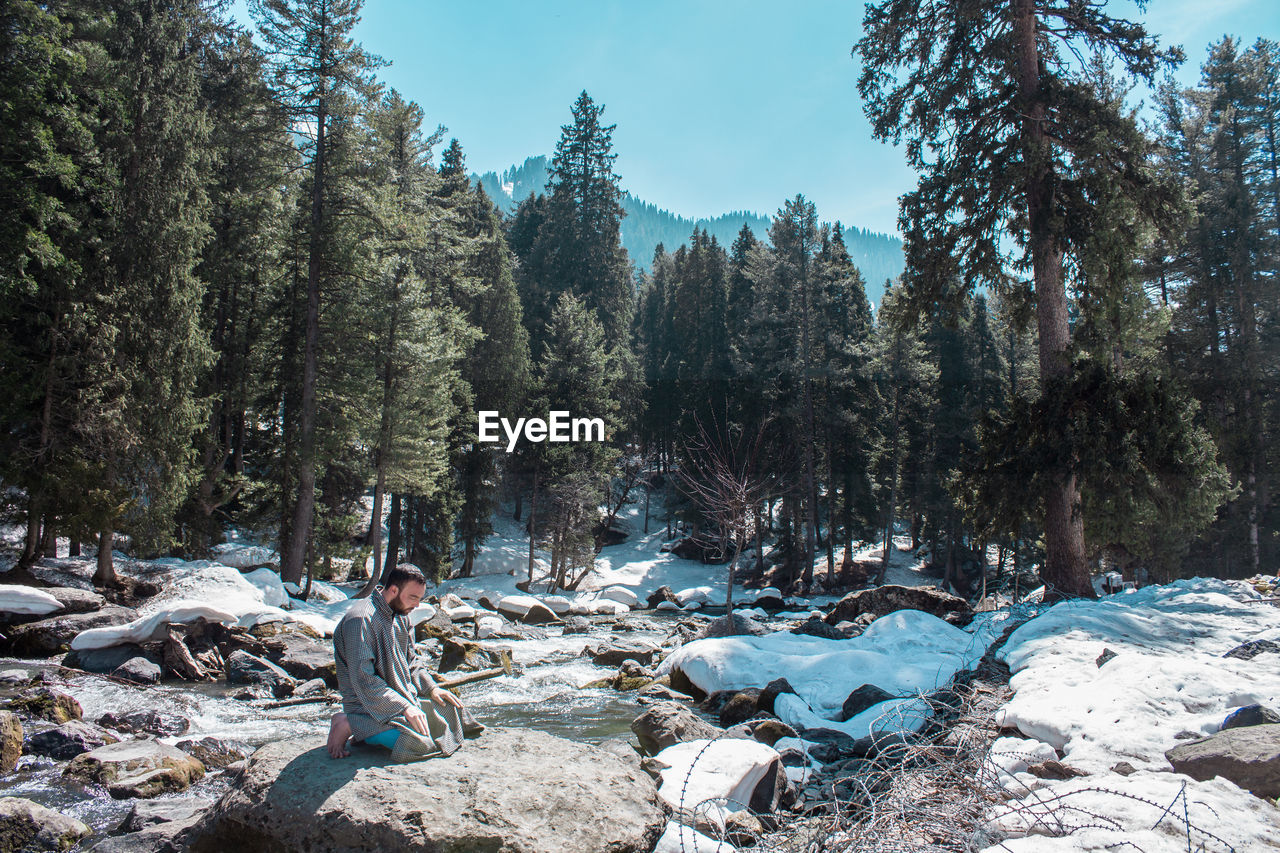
[0,0,1280,597]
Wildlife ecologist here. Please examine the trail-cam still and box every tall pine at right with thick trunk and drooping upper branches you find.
[856,0,1179,597]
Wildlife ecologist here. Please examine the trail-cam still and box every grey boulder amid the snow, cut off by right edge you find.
[1165,725,1280,799]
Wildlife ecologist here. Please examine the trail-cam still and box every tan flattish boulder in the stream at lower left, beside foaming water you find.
[63,740,205,799]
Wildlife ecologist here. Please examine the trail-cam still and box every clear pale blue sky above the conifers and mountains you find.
[233,0,1280,232]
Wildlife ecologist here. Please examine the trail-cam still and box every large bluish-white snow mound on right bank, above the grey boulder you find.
[993,579,1280,772]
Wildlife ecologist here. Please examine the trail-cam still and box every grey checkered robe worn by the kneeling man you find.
[333,587,475,762]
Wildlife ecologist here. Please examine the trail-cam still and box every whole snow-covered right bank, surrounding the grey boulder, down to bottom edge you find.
[987,579,1280,853]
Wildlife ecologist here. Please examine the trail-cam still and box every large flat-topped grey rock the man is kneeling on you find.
[192,729,667,853]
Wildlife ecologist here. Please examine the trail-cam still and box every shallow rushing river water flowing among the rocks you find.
[0,615,675,848]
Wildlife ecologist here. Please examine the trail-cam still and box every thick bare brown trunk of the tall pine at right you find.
[1014,0,1094,599]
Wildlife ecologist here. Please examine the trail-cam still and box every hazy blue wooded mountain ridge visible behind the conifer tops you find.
[471,156,902,305]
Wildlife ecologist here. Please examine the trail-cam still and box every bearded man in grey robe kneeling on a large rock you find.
[328,565,484,761]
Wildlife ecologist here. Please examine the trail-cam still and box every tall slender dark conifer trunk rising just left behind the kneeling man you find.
[280,97,327,583]
